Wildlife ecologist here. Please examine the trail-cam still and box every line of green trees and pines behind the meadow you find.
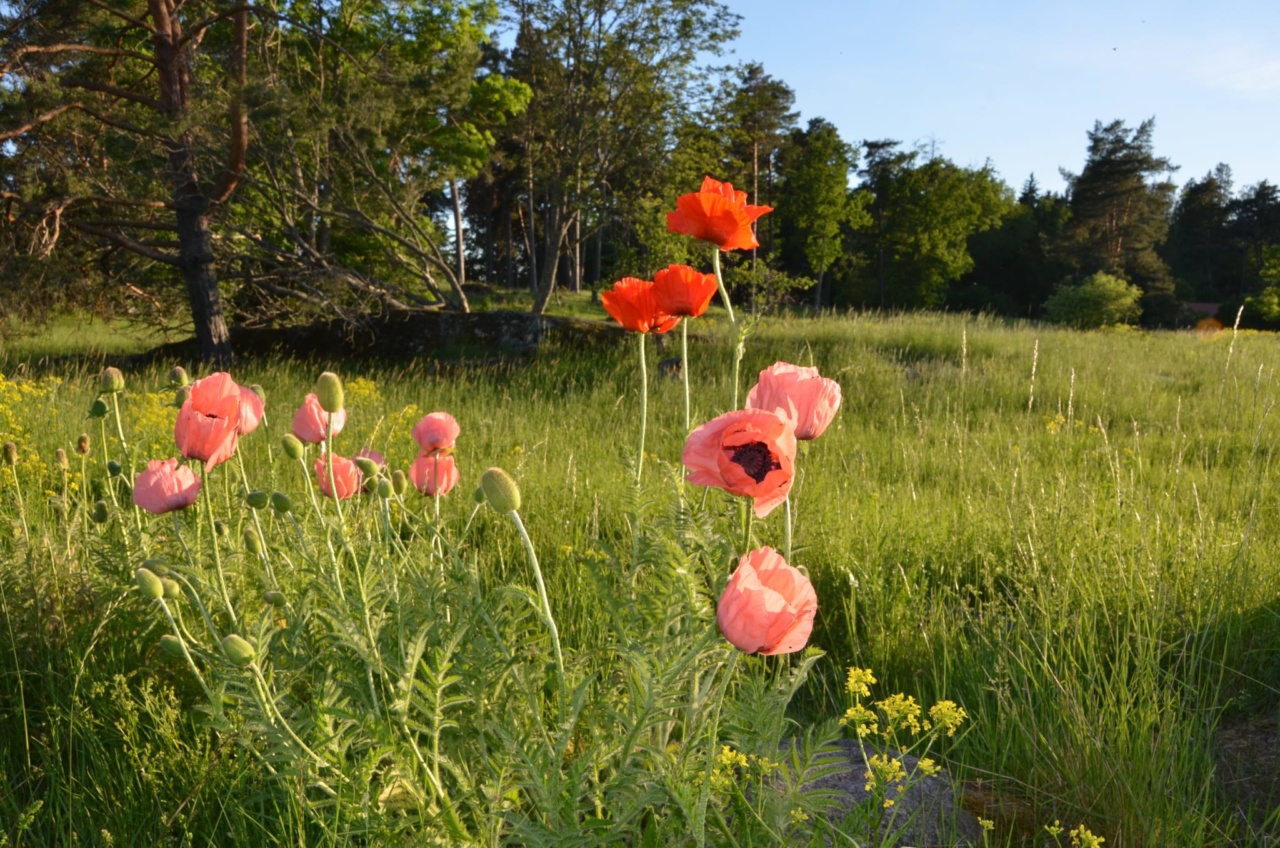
[0,0,1280,359]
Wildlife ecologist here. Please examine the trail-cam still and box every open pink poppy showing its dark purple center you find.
[680,410,796,519]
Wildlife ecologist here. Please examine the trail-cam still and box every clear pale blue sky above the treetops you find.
[727,0,1280,190]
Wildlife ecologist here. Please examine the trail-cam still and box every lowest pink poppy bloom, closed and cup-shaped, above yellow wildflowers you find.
[716,547,818,657]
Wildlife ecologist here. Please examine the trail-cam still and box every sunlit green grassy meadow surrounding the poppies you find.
[0,308,1280,848]
